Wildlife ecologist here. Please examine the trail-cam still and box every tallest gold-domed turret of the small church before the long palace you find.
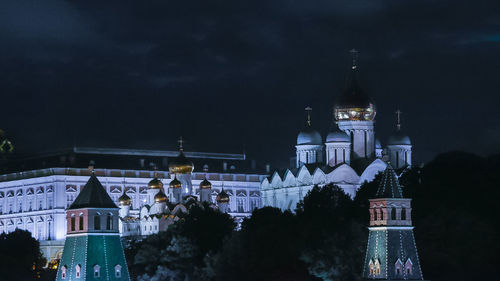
[168,137,194,197]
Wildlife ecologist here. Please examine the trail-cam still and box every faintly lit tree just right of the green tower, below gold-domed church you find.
[125,205,235,280]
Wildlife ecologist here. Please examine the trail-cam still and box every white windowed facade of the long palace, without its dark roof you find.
[0,148,266,260]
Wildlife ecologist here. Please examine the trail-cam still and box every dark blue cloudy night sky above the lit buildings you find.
[0,0,500,166]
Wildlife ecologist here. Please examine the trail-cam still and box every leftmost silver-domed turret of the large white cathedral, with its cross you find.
[295,107,323,168]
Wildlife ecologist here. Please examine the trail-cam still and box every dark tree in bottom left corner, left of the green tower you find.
[0,229,46,281]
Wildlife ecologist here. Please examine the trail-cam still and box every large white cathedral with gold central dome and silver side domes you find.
[260,50,412,211]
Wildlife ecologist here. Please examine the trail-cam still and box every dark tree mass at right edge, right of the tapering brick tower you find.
[401,152,500,281]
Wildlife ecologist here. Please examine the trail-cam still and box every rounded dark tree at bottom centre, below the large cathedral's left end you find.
[214,207,311,281]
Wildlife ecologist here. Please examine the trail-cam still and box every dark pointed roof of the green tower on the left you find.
[68,172,118,210]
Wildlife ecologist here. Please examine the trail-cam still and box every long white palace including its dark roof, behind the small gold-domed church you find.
[0,143,267,260]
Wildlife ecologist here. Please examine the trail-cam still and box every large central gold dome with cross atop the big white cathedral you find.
[335,50,376,121]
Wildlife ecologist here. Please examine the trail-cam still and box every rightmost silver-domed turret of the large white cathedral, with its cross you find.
[387,109,411,169]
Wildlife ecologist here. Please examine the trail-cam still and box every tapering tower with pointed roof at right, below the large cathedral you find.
[363,164,423,280]
